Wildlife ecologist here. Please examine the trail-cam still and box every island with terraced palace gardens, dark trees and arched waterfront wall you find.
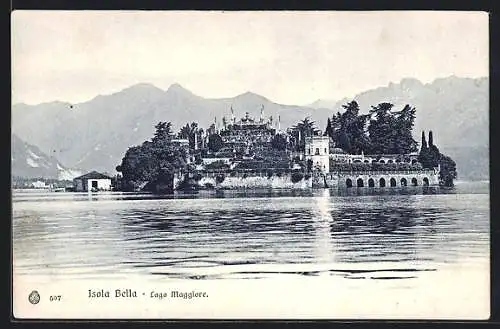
[116,101,457,193]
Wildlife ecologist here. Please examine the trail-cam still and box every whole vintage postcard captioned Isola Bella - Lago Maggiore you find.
[11,10,490,320]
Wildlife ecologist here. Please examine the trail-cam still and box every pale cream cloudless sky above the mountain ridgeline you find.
[11,11,489,105]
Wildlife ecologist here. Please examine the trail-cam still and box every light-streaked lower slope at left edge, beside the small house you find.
[11,135,81,180]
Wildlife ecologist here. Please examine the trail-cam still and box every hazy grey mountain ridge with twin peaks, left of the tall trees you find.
[12,84,329,171]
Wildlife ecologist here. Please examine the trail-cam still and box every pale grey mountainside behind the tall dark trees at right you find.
[328,76,489,180]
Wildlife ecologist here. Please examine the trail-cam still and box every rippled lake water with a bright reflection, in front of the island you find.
[12,182,490,318]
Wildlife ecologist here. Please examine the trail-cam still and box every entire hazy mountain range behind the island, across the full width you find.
[12,76,489,179]
